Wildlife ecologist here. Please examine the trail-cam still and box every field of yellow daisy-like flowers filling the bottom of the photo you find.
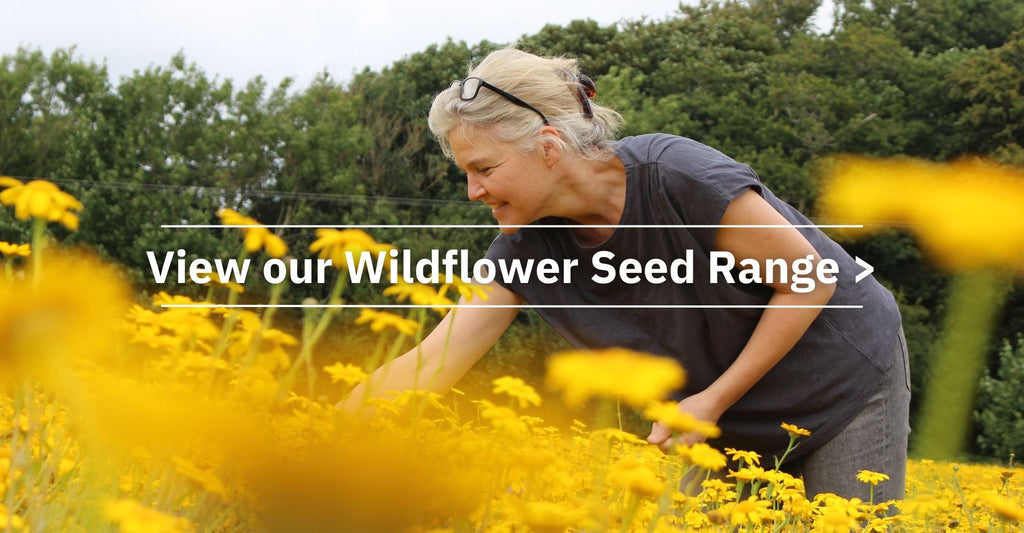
[0,178,1024,532]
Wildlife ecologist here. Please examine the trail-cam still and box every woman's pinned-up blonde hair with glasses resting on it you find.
[427,48,623,160]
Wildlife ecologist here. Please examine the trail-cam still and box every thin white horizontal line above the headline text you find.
[160,224,864,229]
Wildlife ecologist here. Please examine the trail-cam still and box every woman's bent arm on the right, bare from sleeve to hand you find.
[647,190,836,450]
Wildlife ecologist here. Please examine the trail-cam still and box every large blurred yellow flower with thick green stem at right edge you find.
[820,157,1024,459]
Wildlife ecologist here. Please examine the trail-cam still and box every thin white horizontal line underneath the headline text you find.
[160,304,864,309]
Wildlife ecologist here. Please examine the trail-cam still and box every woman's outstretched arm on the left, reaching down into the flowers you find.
[337,282,522,412]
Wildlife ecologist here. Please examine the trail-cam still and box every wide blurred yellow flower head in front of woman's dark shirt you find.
[547,348,686,407]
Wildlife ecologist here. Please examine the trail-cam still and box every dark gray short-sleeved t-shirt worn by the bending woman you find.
[486,134,900,458]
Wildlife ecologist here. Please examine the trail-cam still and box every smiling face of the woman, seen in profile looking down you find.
[449,127,555,233]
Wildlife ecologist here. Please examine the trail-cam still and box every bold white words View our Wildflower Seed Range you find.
[146,248,847,293]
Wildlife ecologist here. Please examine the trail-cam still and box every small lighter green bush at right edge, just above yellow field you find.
[975,335,1024,459]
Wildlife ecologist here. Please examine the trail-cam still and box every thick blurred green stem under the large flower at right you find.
[913,271,1007,460]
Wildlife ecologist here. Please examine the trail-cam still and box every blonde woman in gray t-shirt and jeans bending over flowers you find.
[346,49,909,500]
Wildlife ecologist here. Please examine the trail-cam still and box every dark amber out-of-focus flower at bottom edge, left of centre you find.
[233,431,484,532]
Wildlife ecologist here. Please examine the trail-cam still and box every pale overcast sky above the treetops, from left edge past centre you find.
[0,0,704,86]
